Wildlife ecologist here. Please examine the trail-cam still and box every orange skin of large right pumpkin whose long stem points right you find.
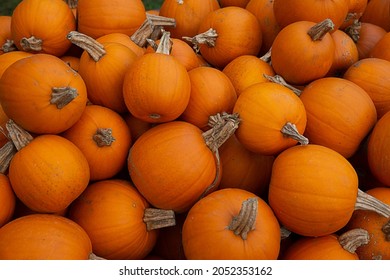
[268,144,358,236]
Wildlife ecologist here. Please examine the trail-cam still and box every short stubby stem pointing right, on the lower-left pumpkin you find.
[143,208,176,231]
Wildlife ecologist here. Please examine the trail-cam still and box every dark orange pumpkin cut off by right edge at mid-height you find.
[367,112,390,186]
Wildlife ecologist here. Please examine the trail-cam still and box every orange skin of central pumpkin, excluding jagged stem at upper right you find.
[128,121,216,212]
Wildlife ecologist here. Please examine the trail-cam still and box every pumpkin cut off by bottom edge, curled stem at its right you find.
[282,229,371,260]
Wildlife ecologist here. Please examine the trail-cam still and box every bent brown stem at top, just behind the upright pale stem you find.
[130,13,176,47]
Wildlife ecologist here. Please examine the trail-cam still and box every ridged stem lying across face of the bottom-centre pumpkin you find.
[228,197,258,240]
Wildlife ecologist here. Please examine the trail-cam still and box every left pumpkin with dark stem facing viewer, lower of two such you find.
[62,105,131,181]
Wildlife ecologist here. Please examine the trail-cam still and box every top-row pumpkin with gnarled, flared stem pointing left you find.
[184,6,262,69]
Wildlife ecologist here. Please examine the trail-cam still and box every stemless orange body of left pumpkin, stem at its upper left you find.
[9,134,90,213]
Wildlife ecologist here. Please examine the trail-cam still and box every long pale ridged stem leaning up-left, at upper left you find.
[67,31,106,62]
